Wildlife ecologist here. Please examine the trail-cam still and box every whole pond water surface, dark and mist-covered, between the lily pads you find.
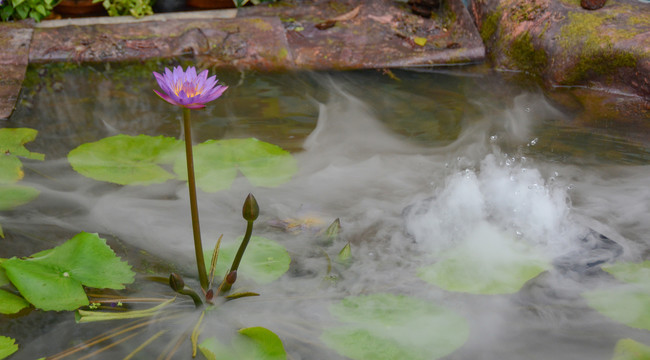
[0,63,650,360]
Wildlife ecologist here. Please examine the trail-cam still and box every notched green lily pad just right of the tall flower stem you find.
[174,138,297,192]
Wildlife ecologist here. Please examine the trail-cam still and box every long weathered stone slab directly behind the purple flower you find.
[30,18,293,69]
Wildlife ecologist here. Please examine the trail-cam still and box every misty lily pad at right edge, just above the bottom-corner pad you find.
[582,285,650,330]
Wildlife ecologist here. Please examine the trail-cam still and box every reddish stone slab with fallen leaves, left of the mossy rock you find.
[237,0,485,69]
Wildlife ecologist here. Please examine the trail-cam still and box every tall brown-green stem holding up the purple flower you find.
[183,108,209,291]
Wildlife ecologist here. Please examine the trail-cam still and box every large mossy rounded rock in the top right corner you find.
[470,0,650,98]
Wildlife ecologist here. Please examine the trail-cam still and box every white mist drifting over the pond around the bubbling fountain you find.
[3,69,650,359]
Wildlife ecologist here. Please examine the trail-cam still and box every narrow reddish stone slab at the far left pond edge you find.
[0,22,33,120]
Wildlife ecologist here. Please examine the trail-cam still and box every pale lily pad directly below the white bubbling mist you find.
[418,223,551,294]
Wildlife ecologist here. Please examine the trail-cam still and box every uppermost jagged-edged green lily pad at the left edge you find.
[0,128,45,184]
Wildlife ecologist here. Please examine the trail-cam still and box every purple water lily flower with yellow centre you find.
[153,66,228,109]
